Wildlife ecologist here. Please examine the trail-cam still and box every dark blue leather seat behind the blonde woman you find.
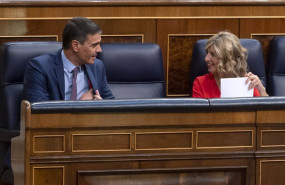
[189,39,266,95]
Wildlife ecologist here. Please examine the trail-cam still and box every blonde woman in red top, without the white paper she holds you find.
[192,31,268,98]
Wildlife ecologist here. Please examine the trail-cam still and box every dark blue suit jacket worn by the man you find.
[24,50,114,102]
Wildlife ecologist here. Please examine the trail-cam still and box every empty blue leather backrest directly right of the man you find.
[97,43,165,99]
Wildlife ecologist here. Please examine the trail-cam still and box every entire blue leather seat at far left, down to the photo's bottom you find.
[0,42,62,184]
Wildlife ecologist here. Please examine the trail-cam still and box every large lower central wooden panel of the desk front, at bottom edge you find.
[73,159,251,185]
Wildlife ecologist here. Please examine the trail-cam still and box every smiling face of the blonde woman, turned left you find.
[205,46,219,74]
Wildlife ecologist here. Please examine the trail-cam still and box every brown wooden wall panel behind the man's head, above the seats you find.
[0,18,156,42]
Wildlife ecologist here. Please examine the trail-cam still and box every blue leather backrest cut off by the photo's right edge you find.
[267,36,285,96]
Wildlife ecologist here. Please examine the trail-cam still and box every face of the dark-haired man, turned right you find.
[77,33,102,64]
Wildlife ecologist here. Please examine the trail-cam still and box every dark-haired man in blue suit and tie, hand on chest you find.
[24,17,114,102]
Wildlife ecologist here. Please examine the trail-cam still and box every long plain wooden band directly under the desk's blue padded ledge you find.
[30,112,255,128]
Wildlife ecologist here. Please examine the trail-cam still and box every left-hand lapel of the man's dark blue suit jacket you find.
[55,50,65,100]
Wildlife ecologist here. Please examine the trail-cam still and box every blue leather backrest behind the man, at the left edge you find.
[0,42,62,130]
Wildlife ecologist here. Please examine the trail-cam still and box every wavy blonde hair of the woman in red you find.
[206,31,247,78]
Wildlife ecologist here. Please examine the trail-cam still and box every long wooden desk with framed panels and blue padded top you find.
[12,98,285,185]
